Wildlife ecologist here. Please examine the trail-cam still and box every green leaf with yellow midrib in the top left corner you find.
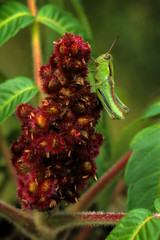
[0,2,35,46]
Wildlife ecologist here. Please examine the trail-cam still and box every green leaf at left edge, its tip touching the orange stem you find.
[0,77,38,124]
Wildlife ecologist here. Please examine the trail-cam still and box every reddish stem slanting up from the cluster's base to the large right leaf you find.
[66,151,132,212]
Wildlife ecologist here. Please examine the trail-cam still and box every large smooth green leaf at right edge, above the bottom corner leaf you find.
[125,124,160,211]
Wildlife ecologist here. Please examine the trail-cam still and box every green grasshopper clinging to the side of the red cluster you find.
[92,36,129,119]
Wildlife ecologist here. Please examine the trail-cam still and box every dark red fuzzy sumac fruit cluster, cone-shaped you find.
[11,33,103,211]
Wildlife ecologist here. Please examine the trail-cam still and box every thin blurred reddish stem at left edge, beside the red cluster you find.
[0,129,16,181]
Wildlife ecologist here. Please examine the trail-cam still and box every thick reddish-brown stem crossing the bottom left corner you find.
[0,201,37,239]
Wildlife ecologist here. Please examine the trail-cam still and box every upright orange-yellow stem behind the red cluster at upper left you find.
[28,0,43,99]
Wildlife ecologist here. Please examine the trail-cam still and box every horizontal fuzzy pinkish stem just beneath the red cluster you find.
[36,212,126,238]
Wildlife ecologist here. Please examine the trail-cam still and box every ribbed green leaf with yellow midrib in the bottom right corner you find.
[106,209,160,240]
